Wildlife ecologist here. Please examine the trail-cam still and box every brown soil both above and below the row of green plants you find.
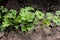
[0,0,60,40]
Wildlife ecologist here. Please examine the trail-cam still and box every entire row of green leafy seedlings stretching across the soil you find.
[0,6,60,31]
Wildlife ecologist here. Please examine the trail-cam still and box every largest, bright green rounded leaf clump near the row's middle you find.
[20,7,34,22]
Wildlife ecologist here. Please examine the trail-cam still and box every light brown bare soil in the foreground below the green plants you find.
[0,26,60,40]
